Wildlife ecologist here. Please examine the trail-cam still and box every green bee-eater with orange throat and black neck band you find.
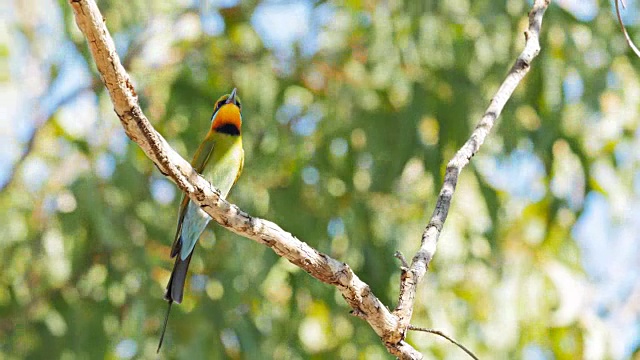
[158,89,244,351]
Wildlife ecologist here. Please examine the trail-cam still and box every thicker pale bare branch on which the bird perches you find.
[70,0,412,359]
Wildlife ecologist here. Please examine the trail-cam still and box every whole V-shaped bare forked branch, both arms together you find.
[70,0,549,359]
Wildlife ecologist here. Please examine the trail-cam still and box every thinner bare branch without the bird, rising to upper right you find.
[393,0,550,329]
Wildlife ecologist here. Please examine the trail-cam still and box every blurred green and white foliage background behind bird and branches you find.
[0,0,640,359]
